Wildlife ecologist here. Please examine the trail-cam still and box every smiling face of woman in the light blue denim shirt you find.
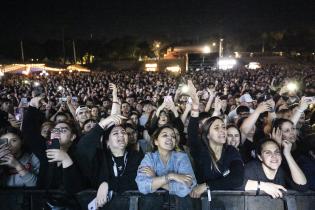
[154,128,176,151]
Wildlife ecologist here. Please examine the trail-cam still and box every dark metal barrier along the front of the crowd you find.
[0,189,315,210]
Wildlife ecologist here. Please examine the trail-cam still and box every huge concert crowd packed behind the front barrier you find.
[0,65,315,209]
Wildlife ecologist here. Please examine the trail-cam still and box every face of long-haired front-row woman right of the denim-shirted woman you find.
[207,119,226,144]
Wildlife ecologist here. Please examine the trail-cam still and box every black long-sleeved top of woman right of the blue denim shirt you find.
[188,117,244,190]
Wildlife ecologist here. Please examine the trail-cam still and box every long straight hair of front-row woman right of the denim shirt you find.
[201,117,223,172]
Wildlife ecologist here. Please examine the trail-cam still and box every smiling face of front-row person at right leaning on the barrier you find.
[258,142,282,170]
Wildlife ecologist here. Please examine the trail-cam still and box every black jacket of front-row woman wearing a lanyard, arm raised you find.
[76,125,143,193]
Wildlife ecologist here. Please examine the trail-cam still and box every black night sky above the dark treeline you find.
[0,0,315,41]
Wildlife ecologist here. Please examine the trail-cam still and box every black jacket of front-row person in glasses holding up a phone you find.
[22,107,85,192]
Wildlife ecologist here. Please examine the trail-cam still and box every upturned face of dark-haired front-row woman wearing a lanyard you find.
[107,126,128,150]
